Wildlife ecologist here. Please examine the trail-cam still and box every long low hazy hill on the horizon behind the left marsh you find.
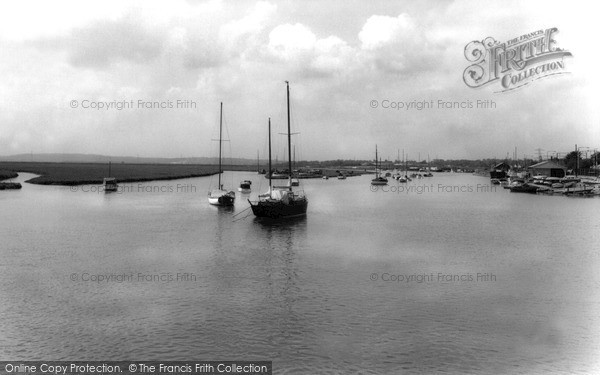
[0,154,266,165]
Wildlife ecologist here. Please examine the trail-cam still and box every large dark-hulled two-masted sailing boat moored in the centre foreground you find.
[248,81,308,219]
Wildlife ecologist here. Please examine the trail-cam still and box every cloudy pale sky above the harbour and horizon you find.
[0,0,600,160]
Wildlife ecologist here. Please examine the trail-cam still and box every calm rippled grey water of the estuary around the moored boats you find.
[0,172,600,374]
